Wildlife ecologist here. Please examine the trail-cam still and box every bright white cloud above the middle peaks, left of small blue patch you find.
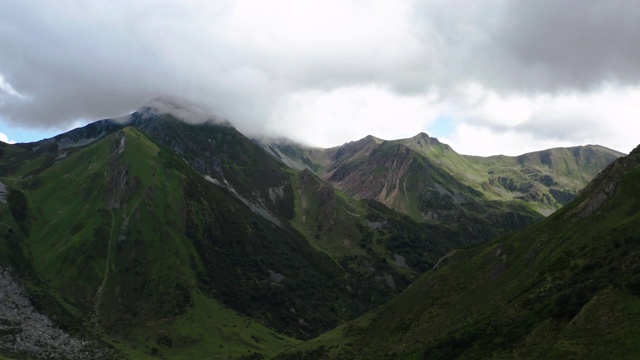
[269,85,439,147]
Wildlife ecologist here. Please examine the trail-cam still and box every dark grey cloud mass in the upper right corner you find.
[496,0,640,89]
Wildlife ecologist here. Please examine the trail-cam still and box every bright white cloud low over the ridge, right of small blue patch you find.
[442,86,640,155]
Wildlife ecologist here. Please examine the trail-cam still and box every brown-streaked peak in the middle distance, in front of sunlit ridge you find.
[276,137,542,244]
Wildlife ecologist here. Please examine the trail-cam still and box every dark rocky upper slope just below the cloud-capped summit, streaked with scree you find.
[128,110,294,221]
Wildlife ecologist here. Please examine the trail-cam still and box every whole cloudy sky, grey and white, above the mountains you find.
[0,0,640,155]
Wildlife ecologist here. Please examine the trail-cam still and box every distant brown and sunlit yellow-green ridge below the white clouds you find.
[301,135,623,221]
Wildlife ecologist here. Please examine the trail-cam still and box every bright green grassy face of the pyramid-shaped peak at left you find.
[0,128,304,359]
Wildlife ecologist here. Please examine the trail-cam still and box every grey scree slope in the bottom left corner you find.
[0,268,110,359]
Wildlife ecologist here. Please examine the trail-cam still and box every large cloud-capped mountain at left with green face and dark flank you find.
[0,109,470,358]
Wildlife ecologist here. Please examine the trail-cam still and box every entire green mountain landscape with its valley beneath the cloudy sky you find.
[0,108,637,359]
